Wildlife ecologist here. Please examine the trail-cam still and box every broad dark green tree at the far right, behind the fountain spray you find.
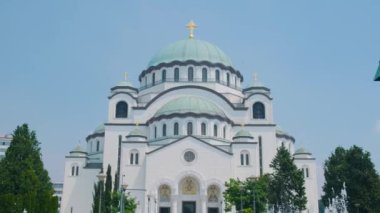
[322,146,380,212]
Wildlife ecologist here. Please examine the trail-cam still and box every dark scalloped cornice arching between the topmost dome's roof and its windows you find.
[139,60,244,82]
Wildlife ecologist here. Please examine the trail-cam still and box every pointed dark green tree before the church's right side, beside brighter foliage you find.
[268,146,307,212]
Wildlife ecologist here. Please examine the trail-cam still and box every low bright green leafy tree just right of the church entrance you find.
[223,176,269,213]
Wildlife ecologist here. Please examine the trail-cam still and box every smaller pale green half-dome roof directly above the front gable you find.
[155,96,226,118]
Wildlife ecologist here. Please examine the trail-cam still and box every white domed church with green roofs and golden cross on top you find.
[61,22,318,213]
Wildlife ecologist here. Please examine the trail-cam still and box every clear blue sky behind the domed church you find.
[0,0,380,195]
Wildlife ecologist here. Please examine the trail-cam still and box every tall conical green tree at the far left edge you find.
[0,124,58,213]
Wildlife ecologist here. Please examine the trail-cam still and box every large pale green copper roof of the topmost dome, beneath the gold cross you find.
[148,39,232,67]
